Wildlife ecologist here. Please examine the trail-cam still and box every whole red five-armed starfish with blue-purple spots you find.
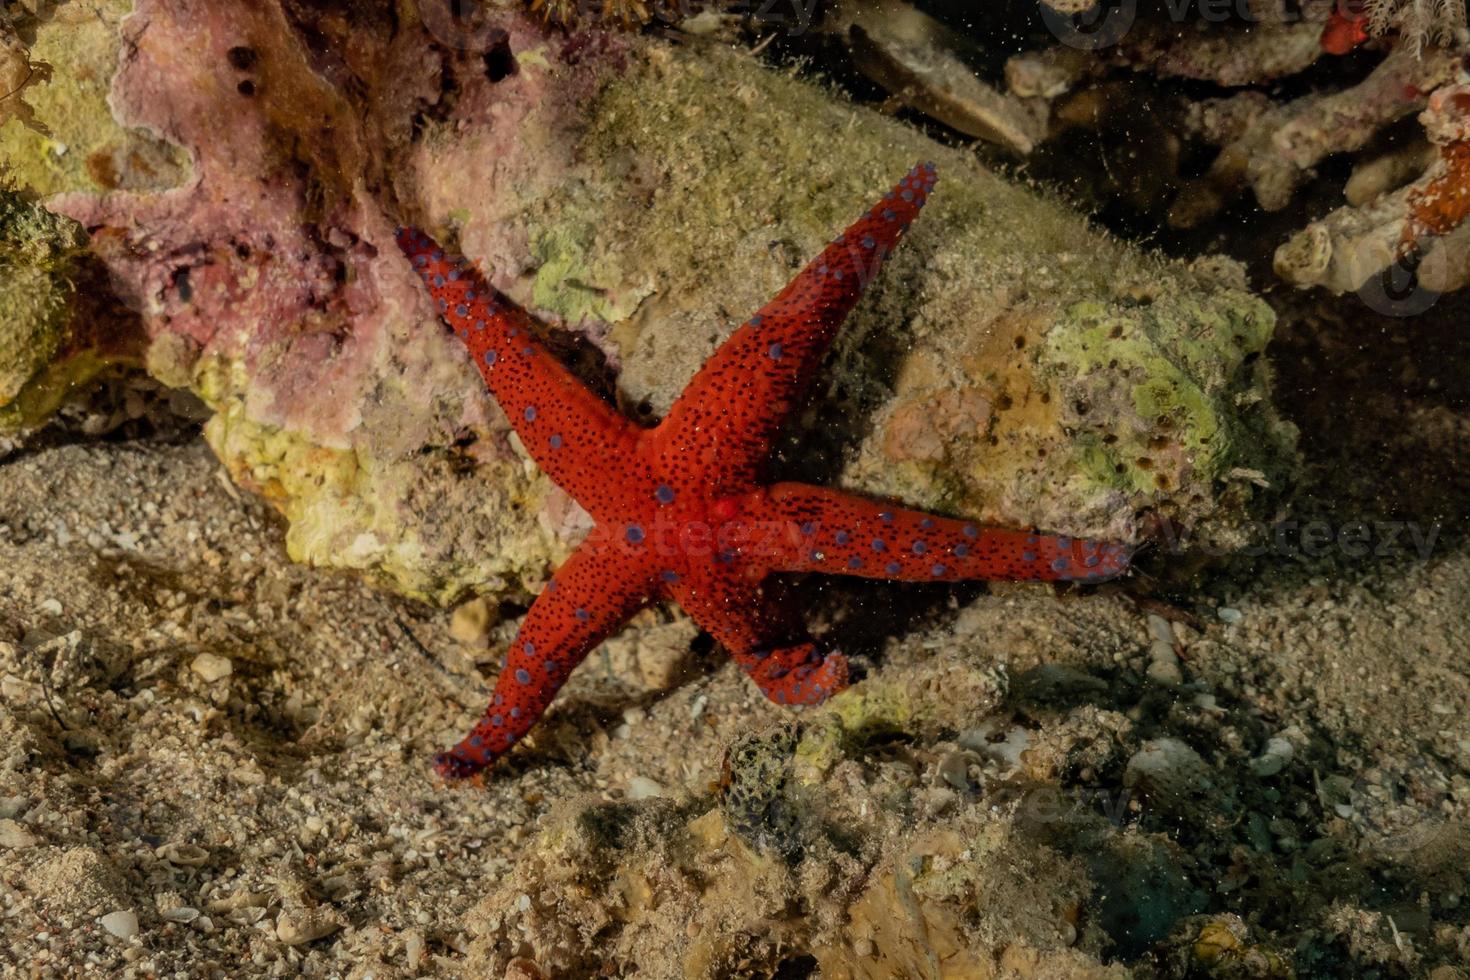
[398,165,1129,779]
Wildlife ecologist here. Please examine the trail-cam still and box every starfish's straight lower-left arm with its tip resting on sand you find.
[434,530,656,779]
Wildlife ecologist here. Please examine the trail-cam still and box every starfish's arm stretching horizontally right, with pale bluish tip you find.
[745,483,1132,582]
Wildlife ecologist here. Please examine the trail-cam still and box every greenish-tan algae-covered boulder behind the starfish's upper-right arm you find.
[552,48,1294,547]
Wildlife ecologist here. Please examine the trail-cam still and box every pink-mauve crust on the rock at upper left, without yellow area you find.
[51,0,542,447]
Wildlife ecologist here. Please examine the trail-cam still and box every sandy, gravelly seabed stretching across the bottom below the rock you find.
[0,302,1470,980]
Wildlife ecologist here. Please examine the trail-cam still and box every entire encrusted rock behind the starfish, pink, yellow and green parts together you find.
[0,0,1292,601]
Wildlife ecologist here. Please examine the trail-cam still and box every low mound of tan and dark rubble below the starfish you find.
[467,593,1470,980]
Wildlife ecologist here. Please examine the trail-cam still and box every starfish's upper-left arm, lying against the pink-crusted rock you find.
[398,229,639,513]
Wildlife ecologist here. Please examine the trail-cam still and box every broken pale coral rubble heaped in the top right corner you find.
[1007,0,1470,296]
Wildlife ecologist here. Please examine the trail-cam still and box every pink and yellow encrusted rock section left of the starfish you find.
[40,0,635,601]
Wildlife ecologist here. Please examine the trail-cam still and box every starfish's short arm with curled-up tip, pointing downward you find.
[669,569,847,705]
